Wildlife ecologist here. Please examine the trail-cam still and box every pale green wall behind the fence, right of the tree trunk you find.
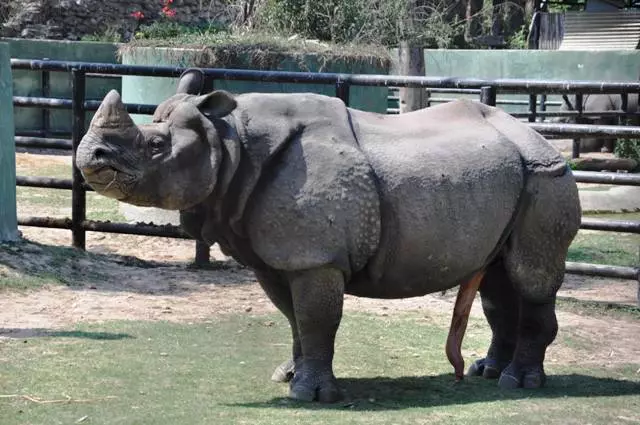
[424,50,640,111]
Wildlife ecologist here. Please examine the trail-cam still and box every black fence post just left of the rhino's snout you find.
[71,69,87,249]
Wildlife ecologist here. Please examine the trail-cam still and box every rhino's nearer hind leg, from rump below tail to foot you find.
[498,173,580,389]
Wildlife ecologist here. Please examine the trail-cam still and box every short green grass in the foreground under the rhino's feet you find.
[0,313,640,425]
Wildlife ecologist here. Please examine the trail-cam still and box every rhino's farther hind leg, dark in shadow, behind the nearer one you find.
[467,259,520,379]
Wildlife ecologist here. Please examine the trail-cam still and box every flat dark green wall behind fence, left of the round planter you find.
[4,39,121,132]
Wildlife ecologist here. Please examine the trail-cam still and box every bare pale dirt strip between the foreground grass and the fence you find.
[0,228,640,366]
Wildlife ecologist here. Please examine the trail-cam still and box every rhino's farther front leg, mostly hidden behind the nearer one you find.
[256,271,302,382]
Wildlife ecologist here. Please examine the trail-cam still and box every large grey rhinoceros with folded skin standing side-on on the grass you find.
[76,69,580,402]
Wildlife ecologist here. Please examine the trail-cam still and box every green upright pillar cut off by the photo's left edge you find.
[0,43,18,241]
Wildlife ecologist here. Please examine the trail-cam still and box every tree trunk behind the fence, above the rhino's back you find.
[397,41,427,114]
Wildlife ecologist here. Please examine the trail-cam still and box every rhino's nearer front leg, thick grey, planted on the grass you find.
[289,268,344,403]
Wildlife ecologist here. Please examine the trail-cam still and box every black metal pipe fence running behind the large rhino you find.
[11,59,640,298]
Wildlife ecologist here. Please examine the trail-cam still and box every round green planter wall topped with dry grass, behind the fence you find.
[122,47,388,122]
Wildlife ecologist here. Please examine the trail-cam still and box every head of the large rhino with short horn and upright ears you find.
[75,74,236,210]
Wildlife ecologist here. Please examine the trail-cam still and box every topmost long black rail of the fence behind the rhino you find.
[11,59,640,94]
